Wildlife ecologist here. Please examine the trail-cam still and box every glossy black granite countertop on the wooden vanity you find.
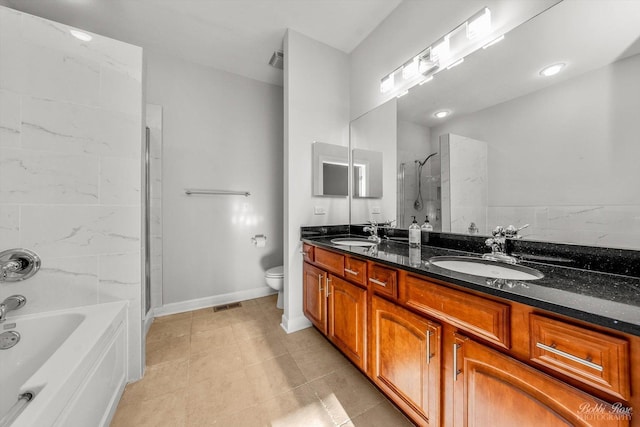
[302,235,640,336]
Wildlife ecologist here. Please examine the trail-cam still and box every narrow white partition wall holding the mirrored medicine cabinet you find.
[282,30,349,332]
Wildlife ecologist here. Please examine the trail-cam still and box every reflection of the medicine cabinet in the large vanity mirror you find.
[353,149,382,198]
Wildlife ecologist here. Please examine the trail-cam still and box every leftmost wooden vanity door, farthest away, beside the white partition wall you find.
[302,262,327,334]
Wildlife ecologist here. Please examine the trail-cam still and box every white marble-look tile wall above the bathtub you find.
[0,6,142,379]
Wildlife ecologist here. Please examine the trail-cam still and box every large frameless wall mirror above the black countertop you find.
[351,0,640,249]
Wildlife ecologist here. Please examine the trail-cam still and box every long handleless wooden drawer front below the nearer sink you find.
[401,276,510,348]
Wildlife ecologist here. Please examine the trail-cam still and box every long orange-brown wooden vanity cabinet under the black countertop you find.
[303,243,640,427]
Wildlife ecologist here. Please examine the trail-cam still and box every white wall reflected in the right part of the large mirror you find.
[431,55,640,249]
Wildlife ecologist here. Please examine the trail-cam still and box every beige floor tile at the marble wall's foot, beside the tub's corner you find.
[122,359,189,404]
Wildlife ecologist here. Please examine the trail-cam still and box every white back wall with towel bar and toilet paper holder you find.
[147,53,283,314]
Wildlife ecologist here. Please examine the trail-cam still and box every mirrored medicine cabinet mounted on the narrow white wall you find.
[311,142,349,197]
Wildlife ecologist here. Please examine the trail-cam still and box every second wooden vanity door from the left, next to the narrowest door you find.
[328,274,367,370]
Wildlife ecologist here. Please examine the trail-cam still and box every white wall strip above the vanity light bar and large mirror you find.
[349,0,558,119]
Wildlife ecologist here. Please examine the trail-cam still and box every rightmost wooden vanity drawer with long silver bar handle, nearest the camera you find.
[529,314,630,399]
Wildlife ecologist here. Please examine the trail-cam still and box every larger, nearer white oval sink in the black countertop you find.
[429,256,544,280]
